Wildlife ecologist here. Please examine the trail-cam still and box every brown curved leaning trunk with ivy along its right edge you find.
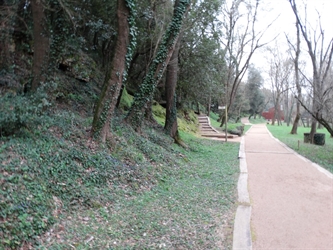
[92,0,131,142]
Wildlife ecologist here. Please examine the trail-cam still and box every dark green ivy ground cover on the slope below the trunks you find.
[0,112,161,247]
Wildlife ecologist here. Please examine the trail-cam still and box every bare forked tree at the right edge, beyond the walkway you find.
[289,0,333,143]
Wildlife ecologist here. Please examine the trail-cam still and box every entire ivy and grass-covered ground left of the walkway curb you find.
[0,92,238,249]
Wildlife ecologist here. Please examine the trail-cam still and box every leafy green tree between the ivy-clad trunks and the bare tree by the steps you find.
[177,0,223,113]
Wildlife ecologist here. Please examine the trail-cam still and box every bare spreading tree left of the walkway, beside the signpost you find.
[221,0,270,126]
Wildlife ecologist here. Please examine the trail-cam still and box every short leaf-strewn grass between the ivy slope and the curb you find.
[35,135,238,249]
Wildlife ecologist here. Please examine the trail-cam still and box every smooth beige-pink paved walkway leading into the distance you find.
[244,124,333,250]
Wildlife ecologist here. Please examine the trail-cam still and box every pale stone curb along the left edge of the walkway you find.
[232,137,252,250]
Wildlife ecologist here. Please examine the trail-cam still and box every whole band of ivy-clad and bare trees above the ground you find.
[0,0,333,145]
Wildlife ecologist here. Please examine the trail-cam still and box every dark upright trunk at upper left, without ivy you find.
[30,0,50,91]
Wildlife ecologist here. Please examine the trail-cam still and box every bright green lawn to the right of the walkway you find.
[267,124,333,173]
